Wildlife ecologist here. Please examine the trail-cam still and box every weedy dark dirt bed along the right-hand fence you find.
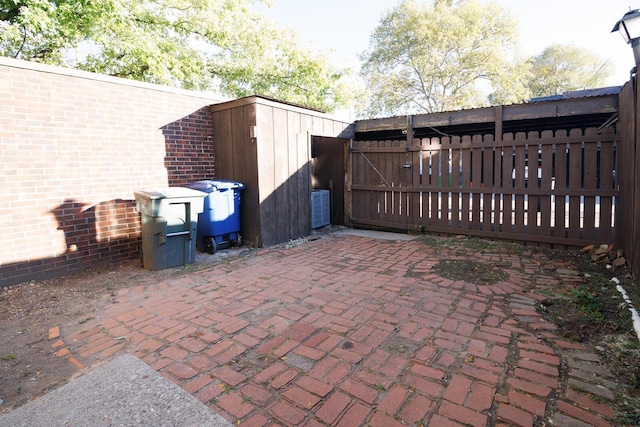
[539,253,640,426]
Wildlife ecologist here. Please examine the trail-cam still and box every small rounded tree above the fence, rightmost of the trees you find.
[527,44,612,97]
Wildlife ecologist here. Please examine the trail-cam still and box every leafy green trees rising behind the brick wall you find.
[0,0,346,110]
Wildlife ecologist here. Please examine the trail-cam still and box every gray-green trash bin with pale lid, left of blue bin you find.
[134,187,206,270]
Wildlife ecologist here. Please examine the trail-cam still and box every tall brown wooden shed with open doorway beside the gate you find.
[211,96,353,247]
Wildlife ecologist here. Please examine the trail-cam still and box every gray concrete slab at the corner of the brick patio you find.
[0,354,232,427]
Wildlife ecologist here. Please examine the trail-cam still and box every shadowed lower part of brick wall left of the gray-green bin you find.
[0,199,140,287]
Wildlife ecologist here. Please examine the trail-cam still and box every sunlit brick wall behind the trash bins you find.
[0,58,221,286]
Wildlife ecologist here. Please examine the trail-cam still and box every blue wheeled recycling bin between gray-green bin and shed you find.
[187,180,244,254]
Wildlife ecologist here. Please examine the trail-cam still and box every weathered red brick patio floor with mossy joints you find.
[55,233,615,427]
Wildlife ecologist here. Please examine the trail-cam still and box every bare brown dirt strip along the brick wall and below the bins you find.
[0,249,250,413]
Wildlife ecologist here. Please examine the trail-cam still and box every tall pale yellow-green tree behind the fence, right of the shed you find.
[361,0,516,116]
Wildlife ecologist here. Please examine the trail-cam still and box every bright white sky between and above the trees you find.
[264,0,640,86]
